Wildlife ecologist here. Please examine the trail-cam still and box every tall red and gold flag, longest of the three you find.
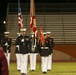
[30,0,38,39]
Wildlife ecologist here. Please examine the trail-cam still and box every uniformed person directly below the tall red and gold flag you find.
[30,33,38,71]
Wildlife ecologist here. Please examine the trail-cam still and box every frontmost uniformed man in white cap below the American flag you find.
[16,28,30,75]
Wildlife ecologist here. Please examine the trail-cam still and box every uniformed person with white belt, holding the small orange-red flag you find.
[39,33,50,73]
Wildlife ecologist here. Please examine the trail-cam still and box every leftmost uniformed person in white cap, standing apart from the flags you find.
[1,32,12,66]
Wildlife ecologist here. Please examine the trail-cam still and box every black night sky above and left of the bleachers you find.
[0,0,76,34]
